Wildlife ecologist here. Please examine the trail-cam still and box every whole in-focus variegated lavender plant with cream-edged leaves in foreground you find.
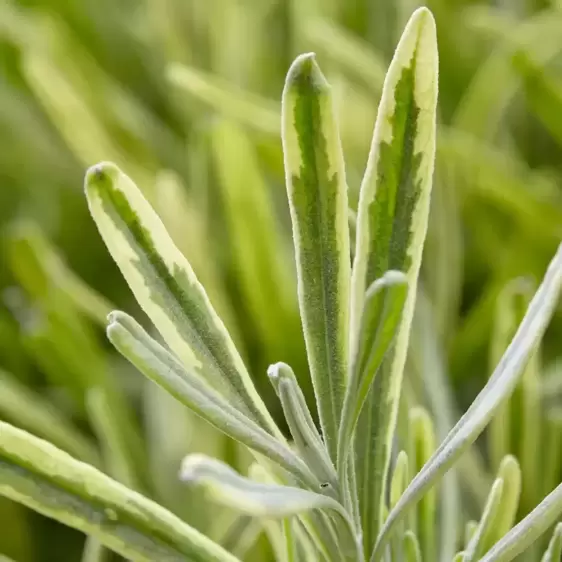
[0,8,562,562]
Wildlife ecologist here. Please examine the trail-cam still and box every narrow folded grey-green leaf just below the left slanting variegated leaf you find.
[107,311,319,489]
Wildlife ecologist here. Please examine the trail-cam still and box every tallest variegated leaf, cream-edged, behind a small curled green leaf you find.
[350,8,437,550]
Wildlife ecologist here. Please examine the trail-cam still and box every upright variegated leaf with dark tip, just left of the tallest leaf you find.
[282,54,350,462]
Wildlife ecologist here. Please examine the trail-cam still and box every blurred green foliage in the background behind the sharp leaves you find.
[0,0,562,562]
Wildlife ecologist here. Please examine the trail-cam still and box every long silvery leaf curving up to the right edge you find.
[372,245,562,562]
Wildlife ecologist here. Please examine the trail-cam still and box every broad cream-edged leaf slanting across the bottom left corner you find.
[0,422,236,562]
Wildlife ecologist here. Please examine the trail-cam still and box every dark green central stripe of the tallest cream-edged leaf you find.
[360,54,422,552]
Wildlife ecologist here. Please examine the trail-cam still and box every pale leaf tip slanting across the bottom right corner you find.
[474,484,562,562]
